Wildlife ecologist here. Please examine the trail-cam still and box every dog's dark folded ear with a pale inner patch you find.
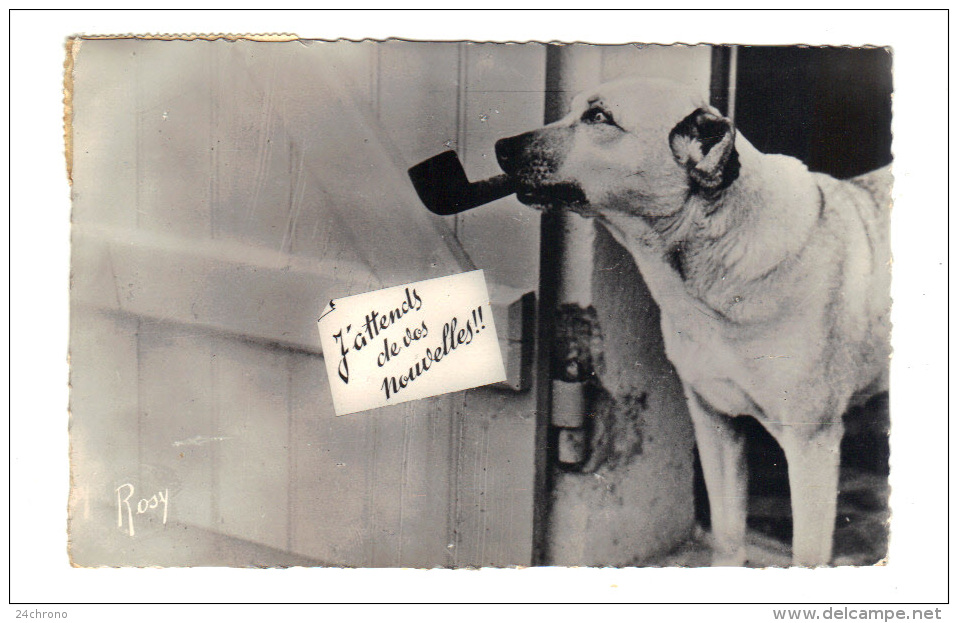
[669,108,739,192]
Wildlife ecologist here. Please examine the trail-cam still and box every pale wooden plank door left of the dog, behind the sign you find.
[73,41,541,567]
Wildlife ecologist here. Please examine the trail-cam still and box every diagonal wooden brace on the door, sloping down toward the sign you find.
[233,41,472,286]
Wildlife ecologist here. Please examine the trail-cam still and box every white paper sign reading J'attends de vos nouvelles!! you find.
[319,270,506,415]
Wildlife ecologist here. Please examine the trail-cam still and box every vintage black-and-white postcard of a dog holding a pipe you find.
[68,38,893,568]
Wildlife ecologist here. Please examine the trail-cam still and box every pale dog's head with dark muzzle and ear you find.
[496,81,738,217]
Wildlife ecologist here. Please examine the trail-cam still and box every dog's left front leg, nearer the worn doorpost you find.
[685,386,748,567]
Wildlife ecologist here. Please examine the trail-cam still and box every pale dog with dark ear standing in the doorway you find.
[496,81,891,566]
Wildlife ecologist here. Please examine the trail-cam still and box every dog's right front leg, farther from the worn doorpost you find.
[779,418,844,567]
